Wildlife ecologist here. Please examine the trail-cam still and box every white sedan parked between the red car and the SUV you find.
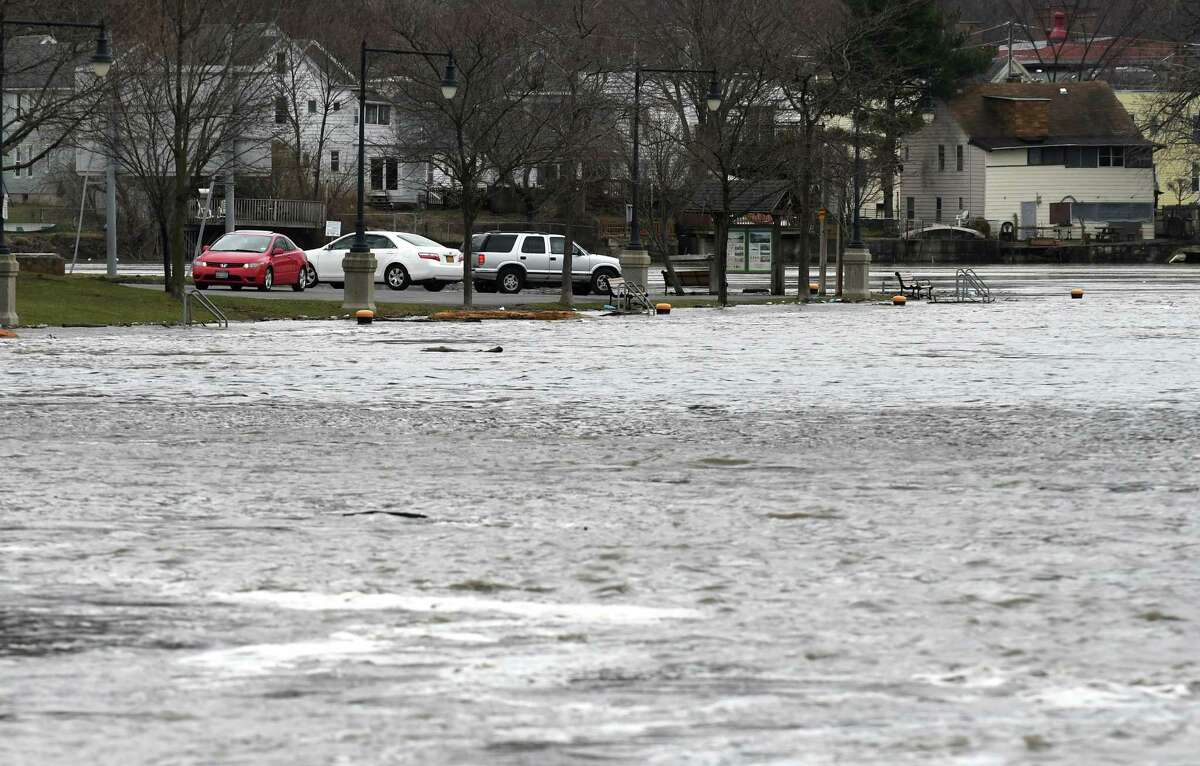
[305,232,462,292]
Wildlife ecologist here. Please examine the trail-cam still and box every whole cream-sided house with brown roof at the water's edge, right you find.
[900,82,1154,239]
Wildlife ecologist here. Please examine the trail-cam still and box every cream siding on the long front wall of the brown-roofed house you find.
[986,149,1154,239]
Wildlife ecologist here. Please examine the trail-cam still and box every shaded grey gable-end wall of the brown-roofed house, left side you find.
[896,102,986,226]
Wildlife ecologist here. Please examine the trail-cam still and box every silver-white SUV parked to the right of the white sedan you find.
[470,232,620,295]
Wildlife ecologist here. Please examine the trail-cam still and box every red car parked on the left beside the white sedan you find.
[192,231,308,293]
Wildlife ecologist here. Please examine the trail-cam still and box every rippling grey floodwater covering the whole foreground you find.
[0,270,1200,766]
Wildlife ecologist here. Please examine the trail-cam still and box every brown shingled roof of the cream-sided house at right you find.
[949,80,1151,151]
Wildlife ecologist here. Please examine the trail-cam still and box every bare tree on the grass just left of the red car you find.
[91,0,283,295]
